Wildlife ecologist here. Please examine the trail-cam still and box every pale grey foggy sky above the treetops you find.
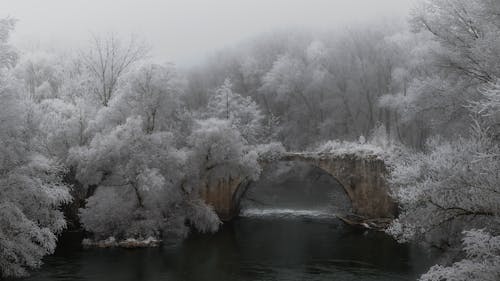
[0,0,413,65]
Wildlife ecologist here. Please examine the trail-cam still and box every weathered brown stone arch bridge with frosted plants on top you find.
[201,153,396,221]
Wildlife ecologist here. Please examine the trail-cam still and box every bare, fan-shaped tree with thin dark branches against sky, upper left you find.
[81,34,149,106]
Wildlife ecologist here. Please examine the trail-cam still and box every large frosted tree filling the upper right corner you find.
[382,0,500,144]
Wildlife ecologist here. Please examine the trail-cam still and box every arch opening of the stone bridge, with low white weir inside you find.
[235,161,352,217]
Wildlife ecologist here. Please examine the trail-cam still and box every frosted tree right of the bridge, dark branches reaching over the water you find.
[389,129,500,248]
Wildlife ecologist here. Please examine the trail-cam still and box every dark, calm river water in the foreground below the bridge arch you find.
[21,213,432,281]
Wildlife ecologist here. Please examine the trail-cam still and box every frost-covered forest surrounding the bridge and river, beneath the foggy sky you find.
[0,0,500,281]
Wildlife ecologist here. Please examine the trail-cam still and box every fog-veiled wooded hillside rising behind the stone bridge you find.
[186,26,399,149]
